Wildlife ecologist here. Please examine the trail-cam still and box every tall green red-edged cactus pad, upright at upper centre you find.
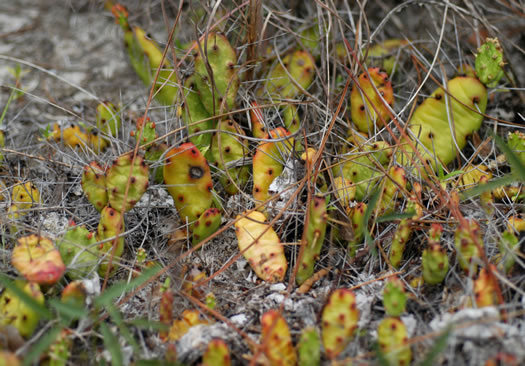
[194,32,240,115]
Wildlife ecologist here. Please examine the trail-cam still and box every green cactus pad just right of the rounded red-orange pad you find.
[57,223,98,280]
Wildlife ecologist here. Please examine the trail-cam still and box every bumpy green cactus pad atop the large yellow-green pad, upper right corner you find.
[476,38,505,88]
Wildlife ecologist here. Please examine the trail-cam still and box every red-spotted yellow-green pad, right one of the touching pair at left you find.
[106,153,149,213]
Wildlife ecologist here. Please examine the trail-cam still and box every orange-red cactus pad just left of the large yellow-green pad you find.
[350,67,394,133]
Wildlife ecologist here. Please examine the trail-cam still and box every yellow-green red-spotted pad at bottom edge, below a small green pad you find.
[377,318,412,366]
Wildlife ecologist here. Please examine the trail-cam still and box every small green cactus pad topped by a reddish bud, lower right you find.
[421,224,449,285]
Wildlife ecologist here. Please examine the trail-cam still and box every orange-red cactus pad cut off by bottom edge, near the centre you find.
[261,310,297,366]
